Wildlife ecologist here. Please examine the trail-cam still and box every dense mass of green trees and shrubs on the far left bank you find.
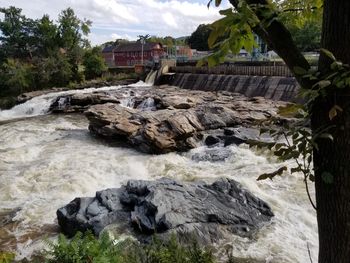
[0,7,92,100]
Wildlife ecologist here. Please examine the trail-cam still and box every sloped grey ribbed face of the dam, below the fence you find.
[165,73,299,102]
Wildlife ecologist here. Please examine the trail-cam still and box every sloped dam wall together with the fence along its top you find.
[157,62,300,102]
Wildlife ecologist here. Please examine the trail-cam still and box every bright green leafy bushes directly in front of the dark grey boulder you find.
[46,233,216,263]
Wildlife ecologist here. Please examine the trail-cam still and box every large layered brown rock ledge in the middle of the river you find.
[81,87,286,154]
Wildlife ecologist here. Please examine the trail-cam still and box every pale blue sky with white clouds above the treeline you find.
[0,0,228,45]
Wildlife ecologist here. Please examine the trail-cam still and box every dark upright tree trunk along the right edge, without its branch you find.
[311,0,350,263]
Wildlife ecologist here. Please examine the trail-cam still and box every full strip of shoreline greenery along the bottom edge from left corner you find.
[0,232,259,263]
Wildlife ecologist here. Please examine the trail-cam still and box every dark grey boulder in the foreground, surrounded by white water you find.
[57,178,273,244]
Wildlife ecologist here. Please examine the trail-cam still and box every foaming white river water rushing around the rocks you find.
[0,87,317,263]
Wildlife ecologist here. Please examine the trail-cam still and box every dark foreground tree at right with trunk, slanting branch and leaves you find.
[208,0,350,263]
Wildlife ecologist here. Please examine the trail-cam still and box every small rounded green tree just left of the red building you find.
[83,47,107,79]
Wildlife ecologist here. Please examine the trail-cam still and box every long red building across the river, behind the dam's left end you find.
[113,42,165,66]
